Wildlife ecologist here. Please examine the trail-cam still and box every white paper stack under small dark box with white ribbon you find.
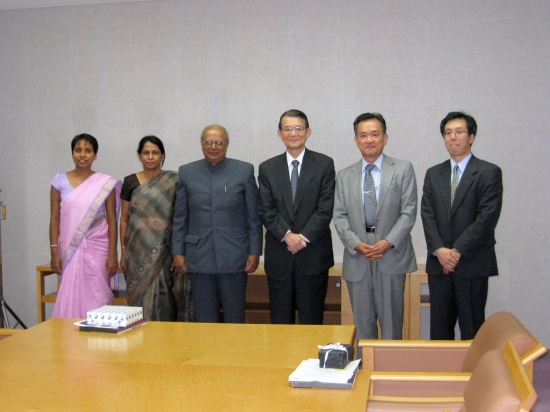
[288,359,361,389]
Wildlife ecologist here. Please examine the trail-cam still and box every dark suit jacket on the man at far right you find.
[421,155,502,279]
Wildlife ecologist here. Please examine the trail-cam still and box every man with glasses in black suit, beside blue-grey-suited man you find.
[258,110,335,324]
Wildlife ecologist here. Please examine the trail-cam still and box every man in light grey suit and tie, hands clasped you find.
[334,113,417,339]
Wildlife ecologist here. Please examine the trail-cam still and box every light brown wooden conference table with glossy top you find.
[0,319,370,412]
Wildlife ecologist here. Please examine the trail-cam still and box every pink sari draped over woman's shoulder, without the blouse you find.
[52,173,121,319]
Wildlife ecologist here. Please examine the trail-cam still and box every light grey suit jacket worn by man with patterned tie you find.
[334,155,417,282]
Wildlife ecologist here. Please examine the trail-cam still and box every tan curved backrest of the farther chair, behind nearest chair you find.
[462,312,546,372]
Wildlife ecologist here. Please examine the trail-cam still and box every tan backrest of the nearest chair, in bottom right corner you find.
[461,341,537,412]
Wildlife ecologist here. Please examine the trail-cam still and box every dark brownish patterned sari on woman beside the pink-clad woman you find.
[124,171,194,321]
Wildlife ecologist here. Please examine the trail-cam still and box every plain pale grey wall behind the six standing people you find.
[0,0,550,346]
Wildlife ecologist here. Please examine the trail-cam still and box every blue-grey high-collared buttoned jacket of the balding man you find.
[172,158,262,273]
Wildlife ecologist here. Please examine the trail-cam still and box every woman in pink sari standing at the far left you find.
[50,134,121,319]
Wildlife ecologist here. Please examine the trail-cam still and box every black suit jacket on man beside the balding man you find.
[258,149,335,280]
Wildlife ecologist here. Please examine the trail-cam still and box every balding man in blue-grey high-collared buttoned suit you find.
[172,125,262,323]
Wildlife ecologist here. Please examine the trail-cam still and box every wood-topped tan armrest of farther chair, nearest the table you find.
[358,339,471,372]
